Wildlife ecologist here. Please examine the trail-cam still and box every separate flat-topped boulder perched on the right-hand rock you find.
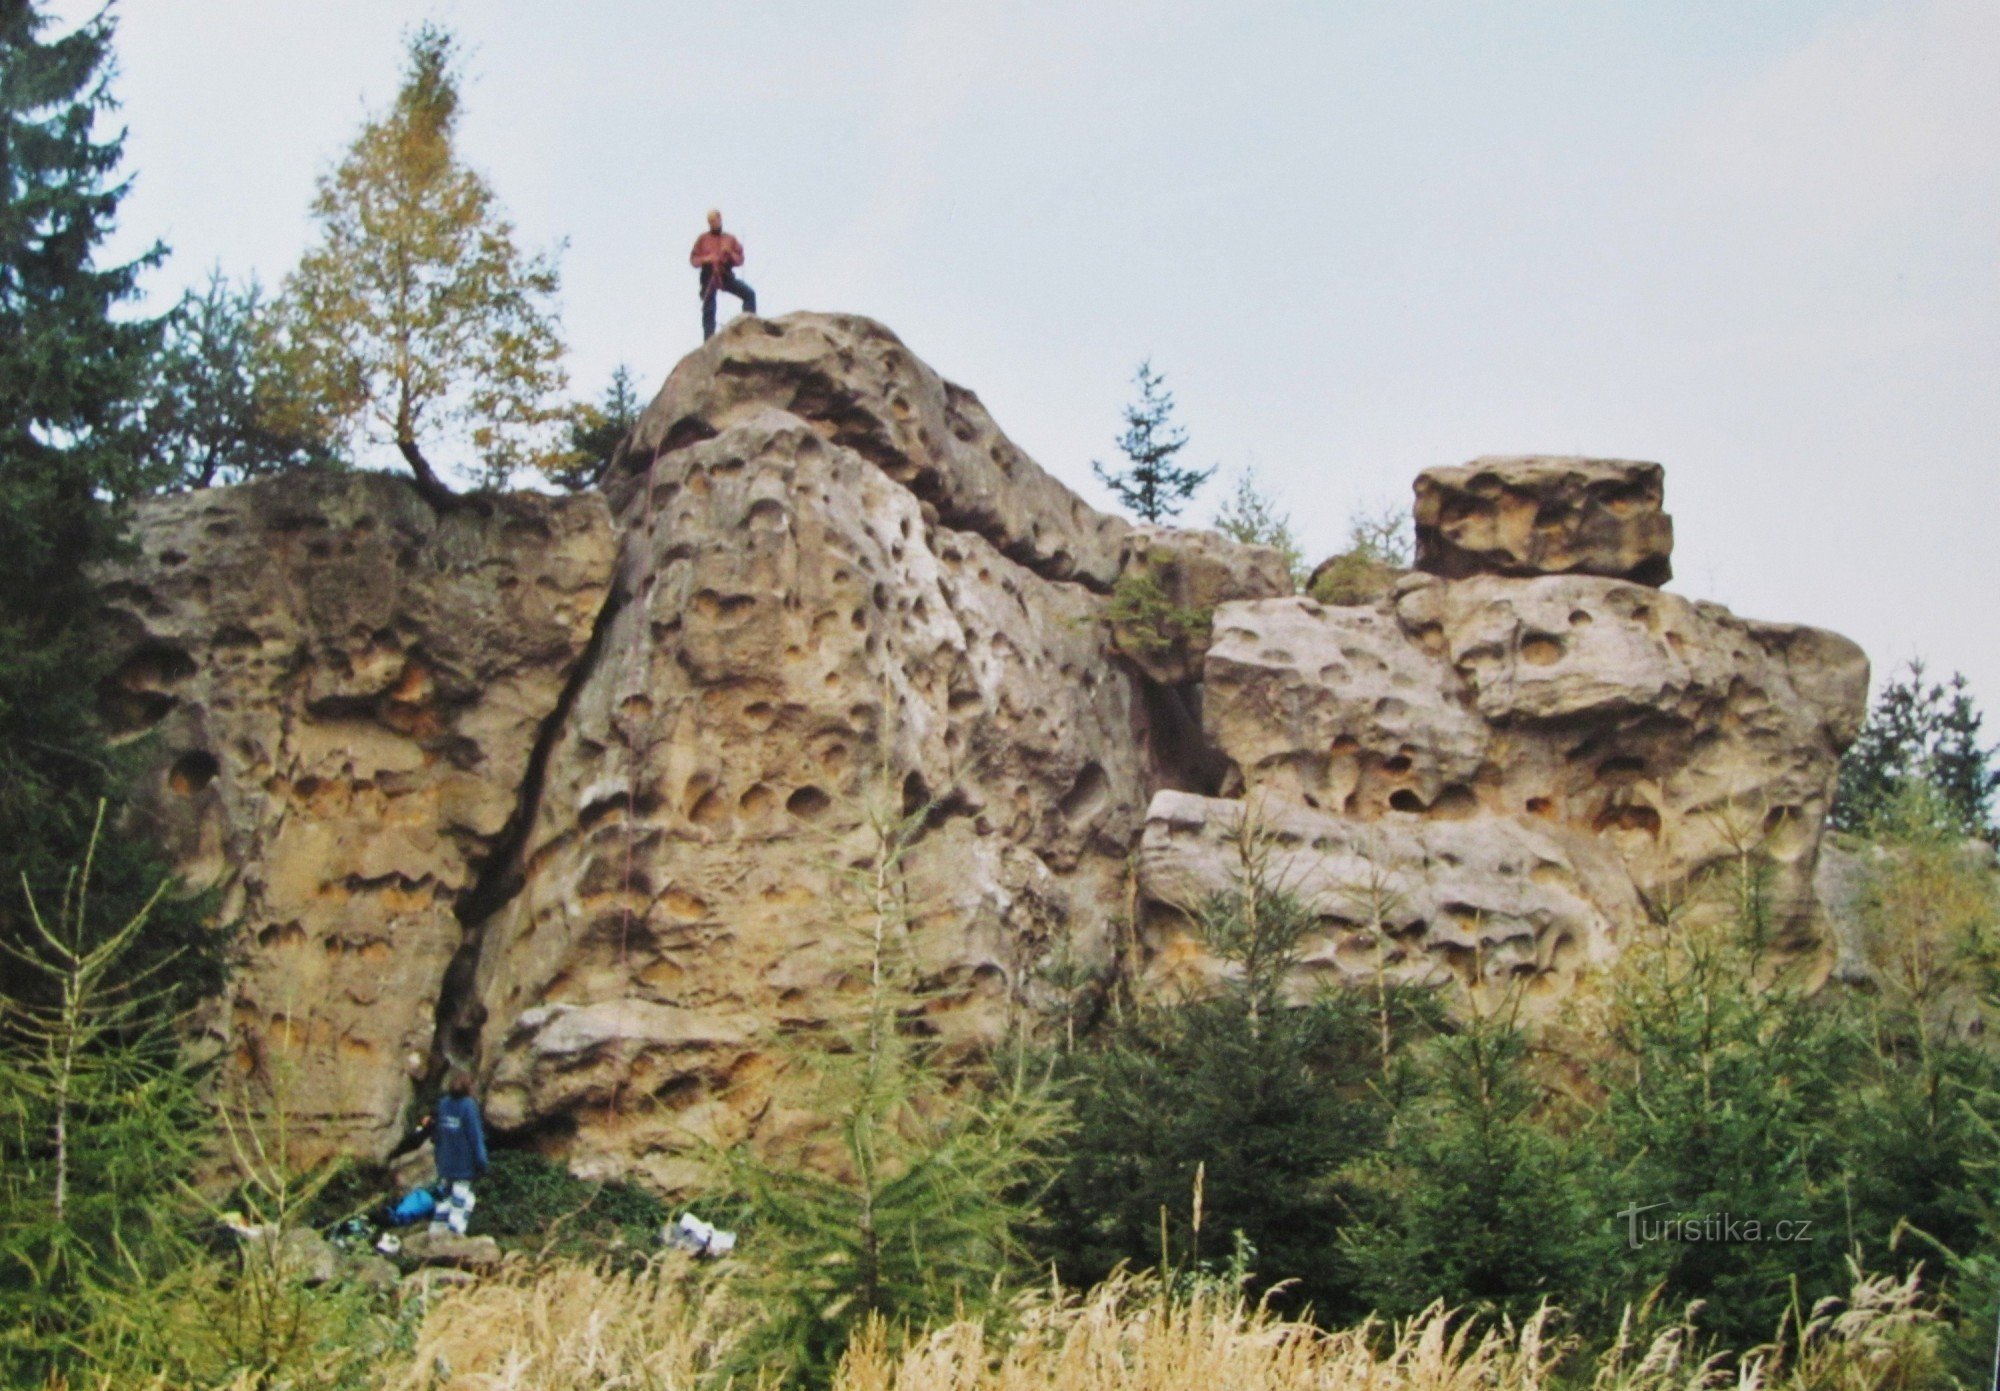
[1416,456,1674,586]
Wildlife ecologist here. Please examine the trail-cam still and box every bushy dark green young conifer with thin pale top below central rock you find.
[1040,819,1434,1319]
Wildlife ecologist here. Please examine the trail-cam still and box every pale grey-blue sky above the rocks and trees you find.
[58,0,2000,715]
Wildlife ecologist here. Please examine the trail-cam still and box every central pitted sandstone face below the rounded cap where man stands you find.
[468,410,1150,1181]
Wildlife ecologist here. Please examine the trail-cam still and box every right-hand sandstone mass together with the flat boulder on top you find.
[1140,460,1868,995]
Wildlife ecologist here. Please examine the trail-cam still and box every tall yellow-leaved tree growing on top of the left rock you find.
[282,24,566,506]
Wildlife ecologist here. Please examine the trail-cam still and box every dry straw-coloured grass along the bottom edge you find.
[356,1263,1936,1391]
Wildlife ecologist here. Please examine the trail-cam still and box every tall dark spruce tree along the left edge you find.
[0,0,218,1015]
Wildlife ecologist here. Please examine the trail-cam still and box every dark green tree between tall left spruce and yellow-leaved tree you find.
[144,272,344,488]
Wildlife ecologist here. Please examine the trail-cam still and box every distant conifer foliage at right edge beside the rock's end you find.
[1830,662,2000,839]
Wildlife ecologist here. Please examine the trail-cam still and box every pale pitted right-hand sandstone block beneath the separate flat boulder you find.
[1140,555,1868,989]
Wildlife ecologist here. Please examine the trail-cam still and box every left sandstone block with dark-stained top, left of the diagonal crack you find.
[104,474,614,1153]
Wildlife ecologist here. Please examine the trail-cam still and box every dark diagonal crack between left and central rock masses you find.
[430,566,630,1079]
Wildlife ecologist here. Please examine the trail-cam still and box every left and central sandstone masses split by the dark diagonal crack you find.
[106,316,1288,1177]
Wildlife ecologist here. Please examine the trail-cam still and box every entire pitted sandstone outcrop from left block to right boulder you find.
[104,314,1868,1187]
